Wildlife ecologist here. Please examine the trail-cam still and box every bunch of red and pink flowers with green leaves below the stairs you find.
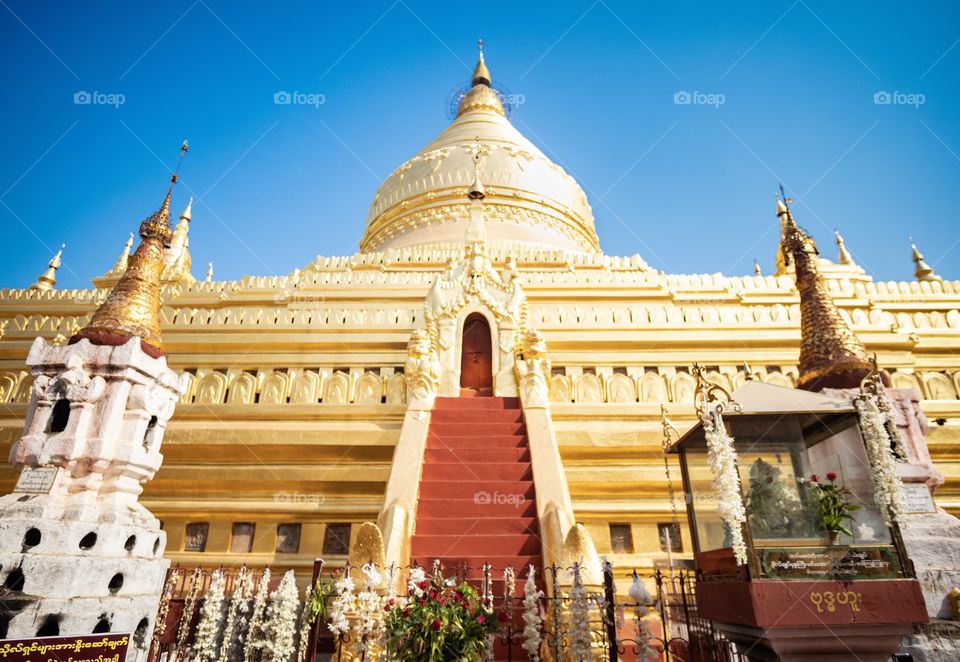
[384,568,500,662]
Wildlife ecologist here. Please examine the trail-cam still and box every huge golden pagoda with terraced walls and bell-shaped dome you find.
[0,46,960,575]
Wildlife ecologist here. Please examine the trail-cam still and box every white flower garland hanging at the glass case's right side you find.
[854,394,906,525]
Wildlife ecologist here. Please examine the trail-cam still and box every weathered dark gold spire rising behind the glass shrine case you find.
[777,200,872,391]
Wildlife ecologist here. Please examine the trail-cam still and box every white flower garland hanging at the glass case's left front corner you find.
[701,407,747,565]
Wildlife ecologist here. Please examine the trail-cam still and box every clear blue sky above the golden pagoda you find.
[0,0,960,287]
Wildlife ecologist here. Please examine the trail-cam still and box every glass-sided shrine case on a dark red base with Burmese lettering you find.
[668,381,927,660]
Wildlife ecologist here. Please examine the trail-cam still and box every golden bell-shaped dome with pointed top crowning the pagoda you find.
[360,51,599,253]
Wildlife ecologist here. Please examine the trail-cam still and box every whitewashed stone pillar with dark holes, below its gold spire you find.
[0,338,186,661]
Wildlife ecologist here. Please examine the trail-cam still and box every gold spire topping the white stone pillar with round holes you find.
[70,140,187,356]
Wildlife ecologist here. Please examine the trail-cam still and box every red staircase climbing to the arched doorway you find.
[411,397,542,602]
